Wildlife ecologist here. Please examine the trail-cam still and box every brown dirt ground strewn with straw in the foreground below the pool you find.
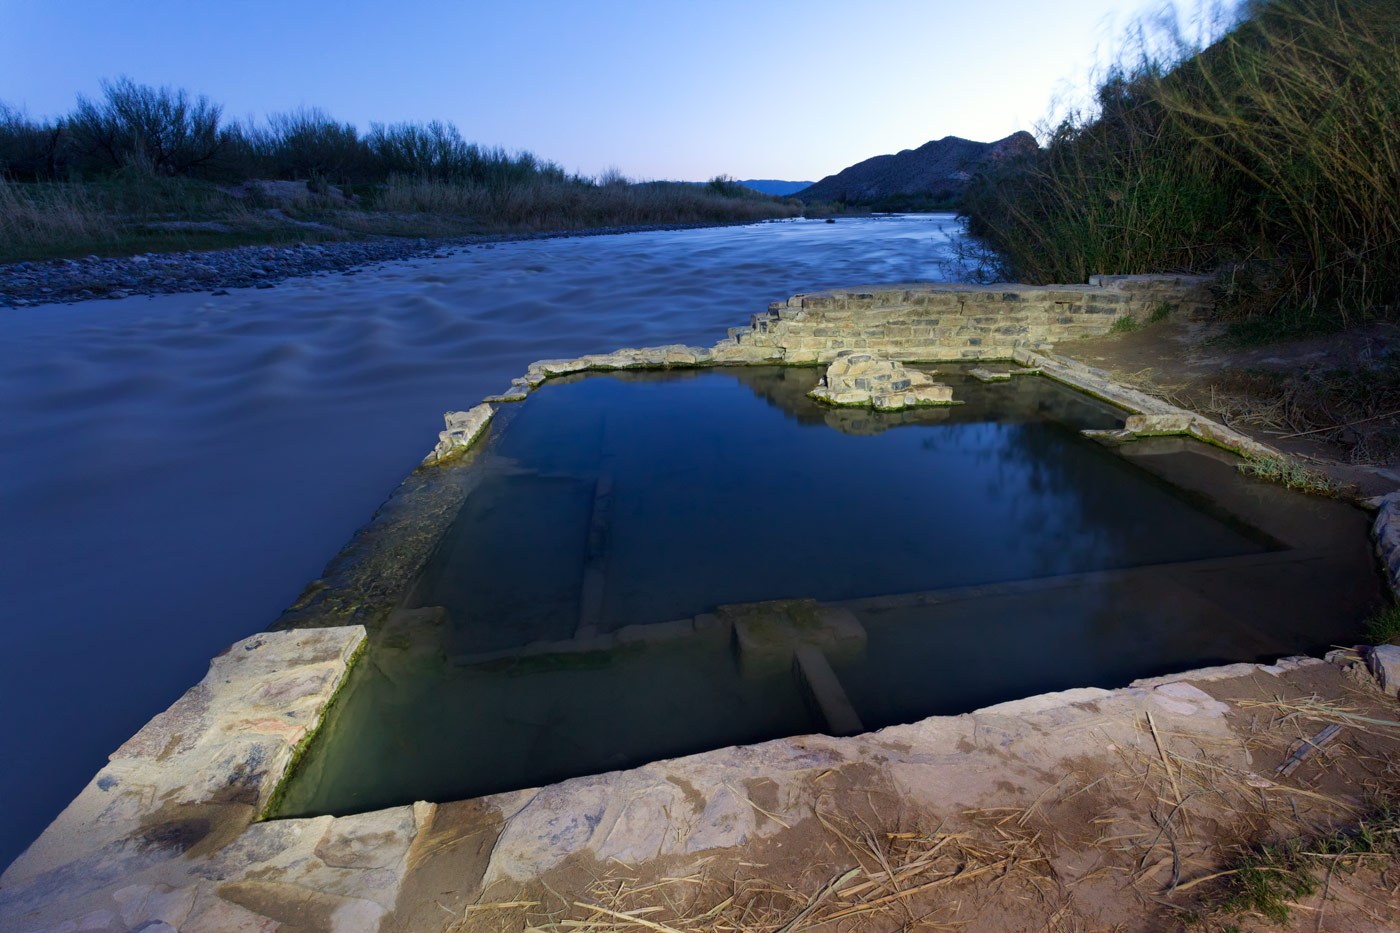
[385,658,1400,933]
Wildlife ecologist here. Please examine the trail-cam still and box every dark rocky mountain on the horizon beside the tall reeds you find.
[795,130,1036,203]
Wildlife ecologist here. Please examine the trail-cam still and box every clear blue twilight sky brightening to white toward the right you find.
[0,0,1198,179]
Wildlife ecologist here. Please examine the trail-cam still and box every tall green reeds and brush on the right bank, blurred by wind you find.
[962,0,1400,339]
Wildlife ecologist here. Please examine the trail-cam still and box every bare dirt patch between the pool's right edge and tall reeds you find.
[1056,315,1400,496]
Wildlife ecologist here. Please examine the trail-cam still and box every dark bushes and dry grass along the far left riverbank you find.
[0,78,802,261]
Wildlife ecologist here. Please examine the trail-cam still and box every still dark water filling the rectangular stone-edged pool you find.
[273,367,1378,814]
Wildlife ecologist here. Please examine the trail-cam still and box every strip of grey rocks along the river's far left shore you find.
[0,224,761,308]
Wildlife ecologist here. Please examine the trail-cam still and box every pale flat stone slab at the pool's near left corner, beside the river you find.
[0,625,378,932]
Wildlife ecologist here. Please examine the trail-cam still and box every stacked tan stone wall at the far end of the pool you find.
[714,276,1212,364]
